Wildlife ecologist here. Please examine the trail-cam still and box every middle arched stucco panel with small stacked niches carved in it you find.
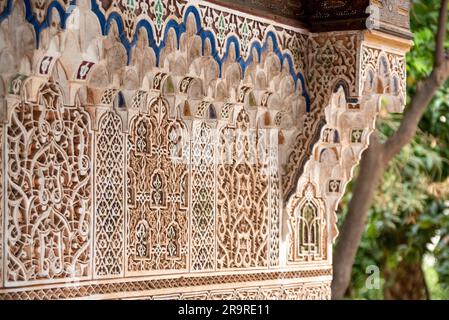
[126,97,189,273]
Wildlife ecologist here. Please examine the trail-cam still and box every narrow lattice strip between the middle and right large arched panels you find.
[191,122,216,271]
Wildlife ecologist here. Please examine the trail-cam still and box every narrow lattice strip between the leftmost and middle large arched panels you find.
[95,112,125,277]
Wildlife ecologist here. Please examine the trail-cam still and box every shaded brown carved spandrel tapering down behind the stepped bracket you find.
[283,32,360,198]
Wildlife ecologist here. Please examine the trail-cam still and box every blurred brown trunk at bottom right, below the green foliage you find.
[384,259,430,300]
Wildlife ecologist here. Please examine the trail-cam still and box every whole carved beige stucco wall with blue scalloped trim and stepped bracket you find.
[0,0,409,299]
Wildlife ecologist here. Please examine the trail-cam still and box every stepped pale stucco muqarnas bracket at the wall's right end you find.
[286,33,406,264]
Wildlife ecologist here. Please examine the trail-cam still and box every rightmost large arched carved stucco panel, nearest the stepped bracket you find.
[217,110,269,269]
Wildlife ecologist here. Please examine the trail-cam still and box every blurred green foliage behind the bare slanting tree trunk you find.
[340,0,449,299]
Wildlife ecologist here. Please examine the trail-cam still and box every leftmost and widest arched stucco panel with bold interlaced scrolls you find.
[6,83,92,285]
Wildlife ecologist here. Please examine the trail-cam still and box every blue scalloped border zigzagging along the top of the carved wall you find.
[0,0,310,112]
